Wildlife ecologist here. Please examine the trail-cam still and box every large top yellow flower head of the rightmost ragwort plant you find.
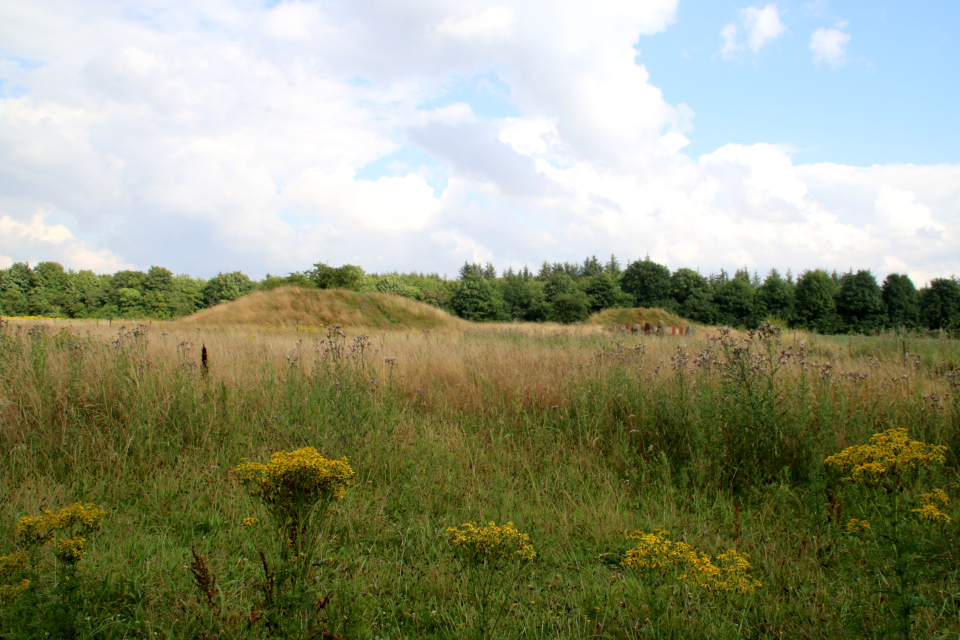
[823,429,947,486]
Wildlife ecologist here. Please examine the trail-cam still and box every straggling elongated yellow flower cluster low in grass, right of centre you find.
[622,529,763,594]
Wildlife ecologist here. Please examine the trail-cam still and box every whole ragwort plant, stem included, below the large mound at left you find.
[233,447,354,632]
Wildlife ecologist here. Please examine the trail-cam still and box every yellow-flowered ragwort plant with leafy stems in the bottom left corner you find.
[0,502,106,638]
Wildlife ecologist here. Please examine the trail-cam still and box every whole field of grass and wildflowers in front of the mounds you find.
[0,296,960,640]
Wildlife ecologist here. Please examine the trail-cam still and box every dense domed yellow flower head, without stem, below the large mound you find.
[233,447,353,507]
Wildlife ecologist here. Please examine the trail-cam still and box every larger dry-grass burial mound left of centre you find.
[180,287,466,329]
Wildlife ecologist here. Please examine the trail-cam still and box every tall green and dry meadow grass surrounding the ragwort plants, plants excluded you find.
[0,321,960,638]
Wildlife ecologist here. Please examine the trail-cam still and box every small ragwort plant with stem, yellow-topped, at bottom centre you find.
[446,522,537,639]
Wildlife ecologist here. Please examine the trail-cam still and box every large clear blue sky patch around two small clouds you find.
[637,0,960,166]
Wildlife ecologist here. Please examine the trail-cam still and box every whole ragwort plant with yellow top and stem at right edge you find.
[824,428,952,638]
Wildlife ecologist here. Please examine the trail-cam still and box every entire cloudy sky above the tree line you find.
[0,0,960,286]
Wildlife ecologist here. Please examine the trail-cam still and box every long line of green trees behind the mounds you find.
[0,256,960,334]
